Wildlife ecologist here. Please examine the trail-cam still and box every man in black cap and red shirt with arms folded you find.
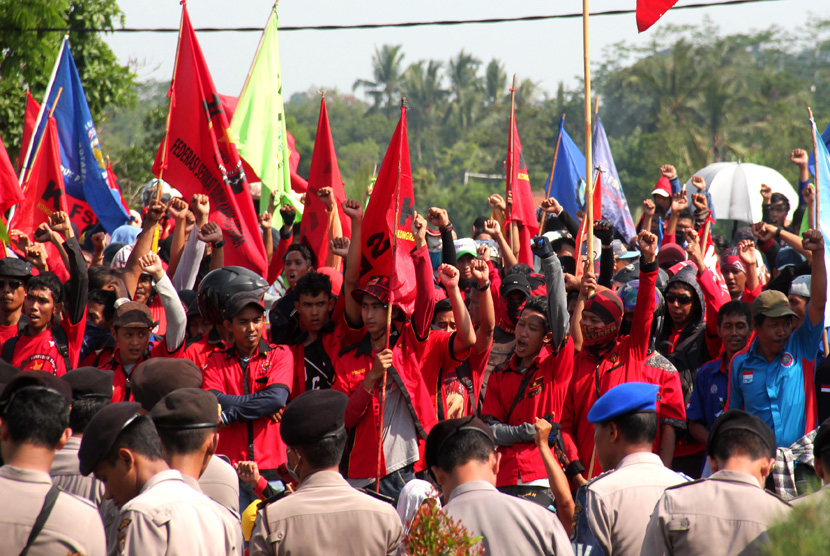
[202,292,294,508]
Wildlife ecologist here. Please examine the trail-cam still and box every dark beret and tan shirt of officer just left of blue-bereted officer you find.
[424,417,573,556]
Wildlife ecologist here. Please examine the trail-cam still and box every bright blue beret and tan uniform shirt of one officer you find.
[572,382,686,556]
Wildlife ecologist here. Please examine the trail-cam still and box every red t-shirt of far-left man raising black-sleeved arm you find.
[11,318,86,376]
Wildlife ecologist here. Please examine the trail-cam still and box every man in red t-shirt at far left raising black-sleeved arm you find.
[2,212,89,376]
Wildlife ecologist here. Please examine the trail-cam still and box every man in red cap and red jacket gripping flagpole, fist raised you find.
[334,200,437,500]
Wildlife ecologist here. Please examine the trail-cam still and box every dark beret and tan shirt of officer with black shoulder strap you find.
[0,371,106,556]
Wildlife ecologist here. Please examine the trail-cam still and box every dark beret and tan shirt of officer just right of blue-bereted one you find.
[641,410,790,556]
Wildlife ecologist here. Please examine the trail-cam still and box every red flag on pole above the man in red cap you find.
[360,102,415,315]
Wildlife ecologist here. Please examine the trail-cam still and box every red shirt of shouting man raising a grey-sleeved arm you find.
[481,338,574,487]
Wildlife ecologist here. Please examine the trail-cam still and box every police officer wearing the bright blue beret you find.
[573,382,686,556]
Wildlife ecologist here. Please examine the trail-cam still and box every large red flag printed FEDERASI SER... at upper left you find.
[153,5,268,276]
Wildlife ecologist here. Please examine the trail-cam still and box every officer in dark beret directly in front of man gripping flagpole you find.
[250,390,403,556]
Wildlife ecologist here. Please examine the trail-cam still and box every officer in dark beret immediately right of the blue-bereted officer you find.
[640,409,790,556]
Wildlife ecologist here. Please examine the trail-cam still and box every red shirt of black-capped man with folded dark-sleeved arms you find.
[202,342,294,470]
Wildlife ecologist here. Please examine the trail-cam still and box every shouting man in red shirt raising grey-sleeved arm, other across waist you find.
[481,238,573,507]
